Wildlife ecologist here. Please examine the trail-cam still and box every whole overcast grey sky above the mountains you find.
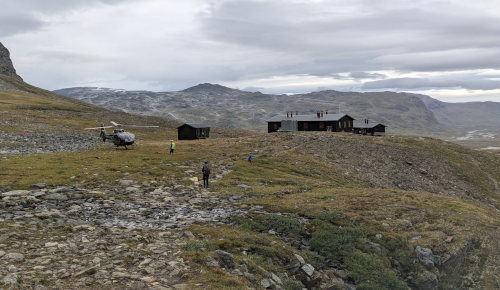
[0,0,500,102]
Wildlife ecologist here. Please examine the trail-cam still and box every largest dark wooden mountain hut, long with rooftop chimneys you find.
[267,111,354,133]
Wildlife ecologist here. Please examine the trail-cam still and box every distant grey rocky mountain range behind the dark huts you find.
[54,83,500,135]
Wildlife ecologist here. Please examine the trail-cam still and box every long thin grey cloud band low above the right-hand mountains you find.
[362,78,500,90]
